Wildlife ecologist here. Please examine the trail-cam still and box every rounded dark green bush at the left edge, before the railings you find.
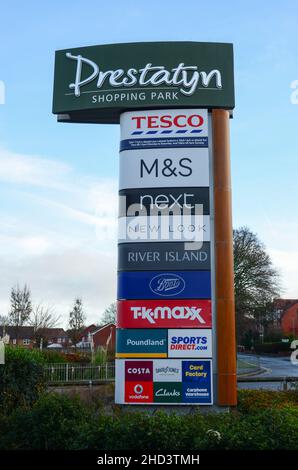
[0,347,45,413]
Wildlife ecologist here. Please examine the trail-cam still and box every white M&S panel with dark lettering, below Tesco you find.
[119,148,209,189]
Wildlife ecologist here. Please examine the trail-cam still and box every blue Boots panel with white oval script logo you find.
[118,271,211,299]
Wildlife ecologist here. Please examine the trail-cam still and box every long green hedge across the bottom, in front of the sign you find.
[0,391,298,452]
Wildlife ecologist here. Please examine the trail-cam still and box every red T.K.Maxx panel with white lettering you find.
[117,299,212,328]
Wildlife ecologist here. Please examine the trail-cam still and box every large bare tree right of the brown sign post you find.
[234,227,280,338]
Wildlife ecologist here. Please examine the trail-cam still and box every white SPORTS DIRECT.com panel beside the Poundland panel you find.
[168,329,212,359]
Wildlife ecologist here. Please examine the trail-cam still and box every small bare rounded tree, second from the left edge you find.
[29,304,60,345]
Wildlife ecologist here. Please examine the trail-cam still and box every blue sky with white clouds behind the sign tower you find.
[0,0,298,321]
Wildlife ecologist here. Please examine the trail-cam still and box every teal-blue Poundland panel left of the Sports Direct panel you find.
[116,328,168,357]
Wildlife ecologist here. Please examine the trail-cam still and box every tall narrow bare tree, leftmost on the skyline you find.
[8,284,32,340]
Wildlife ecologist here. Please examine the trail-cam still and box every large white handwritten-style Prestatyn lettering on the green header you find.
[66,52,222,97]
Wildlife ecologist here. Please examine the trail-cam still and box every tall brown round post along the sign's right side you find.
[212,109,237,406]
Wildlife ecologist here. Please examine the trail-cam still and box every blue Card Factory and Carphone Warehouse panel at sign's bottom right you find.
[182,360,213,405]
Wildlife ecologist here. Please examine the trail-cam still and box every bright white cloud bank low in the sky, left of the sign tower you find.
[0,150,118,322]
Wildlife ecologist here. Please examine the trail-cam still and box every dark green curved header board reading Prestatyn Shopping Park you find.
[53,42,234,123]
